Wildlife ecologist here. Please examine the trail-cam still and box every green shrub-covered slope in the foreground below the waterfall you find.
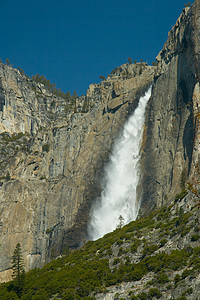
[0,191,200,300]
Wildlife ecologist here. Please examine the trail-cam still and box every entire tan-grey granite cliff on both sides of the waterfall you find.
[0,0,200,286]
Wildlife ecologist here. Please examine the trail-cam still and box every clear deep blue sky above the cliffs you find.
[0,0,193,95]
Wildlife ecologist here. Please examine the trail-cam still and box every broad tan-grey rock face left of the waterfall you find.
[0,63,155,280]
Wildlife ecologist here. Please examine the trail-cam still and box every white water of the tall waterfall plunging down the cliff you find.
[88,87,151,240]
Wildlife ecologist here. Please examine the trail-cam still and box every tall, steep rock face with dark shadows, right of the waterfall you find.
[141,1,200,213]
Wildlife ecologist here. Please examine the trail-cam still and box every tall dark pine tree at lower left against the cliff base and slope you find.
[12,243,24,284]
